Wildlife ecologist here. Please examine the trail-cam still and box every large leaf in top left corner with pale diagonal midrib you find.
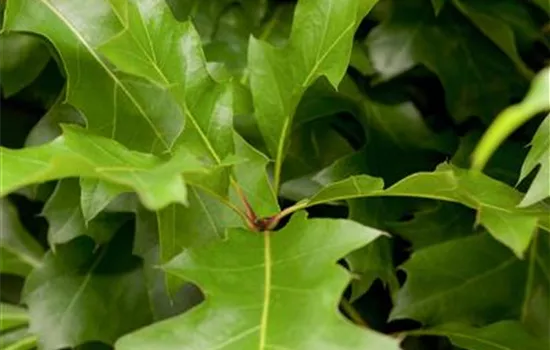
[4,0,184,153]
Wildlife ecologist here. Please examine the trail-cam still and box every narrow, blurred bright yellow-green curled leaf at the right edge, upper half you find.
[472,67,550,169]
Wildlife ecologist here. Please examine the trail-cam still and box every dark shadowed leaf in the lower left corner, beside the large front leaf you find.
[23,228,151,350]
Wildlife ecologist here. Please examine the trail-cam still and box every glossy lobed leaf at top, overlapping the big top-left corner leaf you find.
[101,0,233,196]
